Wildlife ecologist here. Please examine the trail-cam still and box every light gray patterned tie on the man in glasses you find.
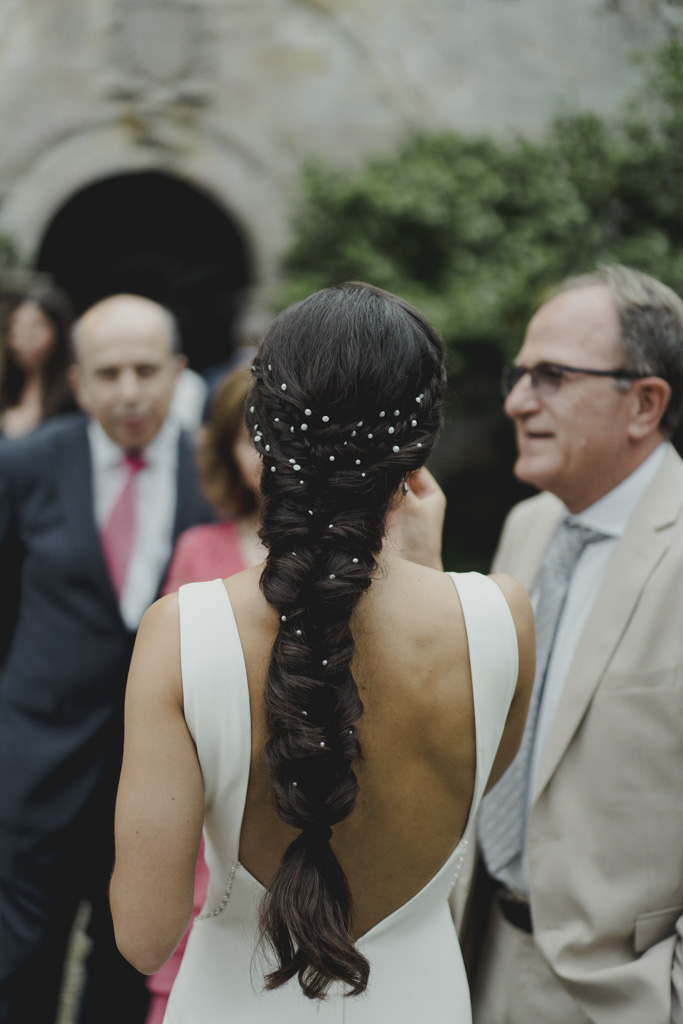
[479,519,605,878]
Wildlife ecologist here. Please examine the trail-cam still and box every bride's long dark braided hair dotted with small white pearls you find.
[247,284,443,998]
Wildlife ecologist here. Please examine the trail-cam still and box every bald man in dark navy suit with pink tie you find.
[0,295,211,1024]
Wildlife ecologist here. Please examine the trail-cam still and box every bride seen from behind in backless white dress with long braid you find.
[112,283,533,1024]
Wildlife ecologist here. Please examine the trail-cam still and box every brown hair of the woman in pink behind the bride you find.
[198,369,256,516]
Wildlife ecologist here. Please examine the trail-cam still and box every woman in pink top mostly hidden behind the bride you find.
[145,370,265,1024]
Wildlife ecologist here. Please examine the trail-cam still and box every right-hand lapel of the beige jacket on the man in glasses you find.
[533,449,683,803]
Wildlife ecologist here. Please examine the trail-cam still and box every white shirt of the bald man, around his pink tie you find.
[88,419,180,630]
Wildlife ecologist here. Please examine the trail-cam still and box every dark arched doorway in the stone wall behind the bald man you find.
[36,172,252,370]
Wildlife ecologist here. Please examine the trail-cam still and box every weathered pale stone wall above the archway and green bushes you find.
[0,0,681,311]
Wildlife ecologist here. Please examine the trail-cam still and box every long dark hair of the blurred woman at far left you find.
[0,288,76,420]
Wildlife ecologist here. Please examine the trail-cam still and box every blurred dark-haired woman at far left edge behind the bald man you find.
[0,288,76,437]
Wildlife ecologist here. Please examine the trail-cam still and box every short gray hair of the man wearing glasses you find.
[551,263,683,436]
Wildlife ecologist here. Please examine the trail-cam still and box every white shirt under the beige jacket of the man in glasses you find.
[499,443,667,895]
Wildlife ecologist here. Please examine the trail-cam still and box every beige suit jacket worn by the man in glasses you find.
[462,446,683,1024]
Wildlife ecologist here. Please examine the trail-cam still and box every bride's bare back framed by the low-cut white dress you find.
[225,557,528,936]
